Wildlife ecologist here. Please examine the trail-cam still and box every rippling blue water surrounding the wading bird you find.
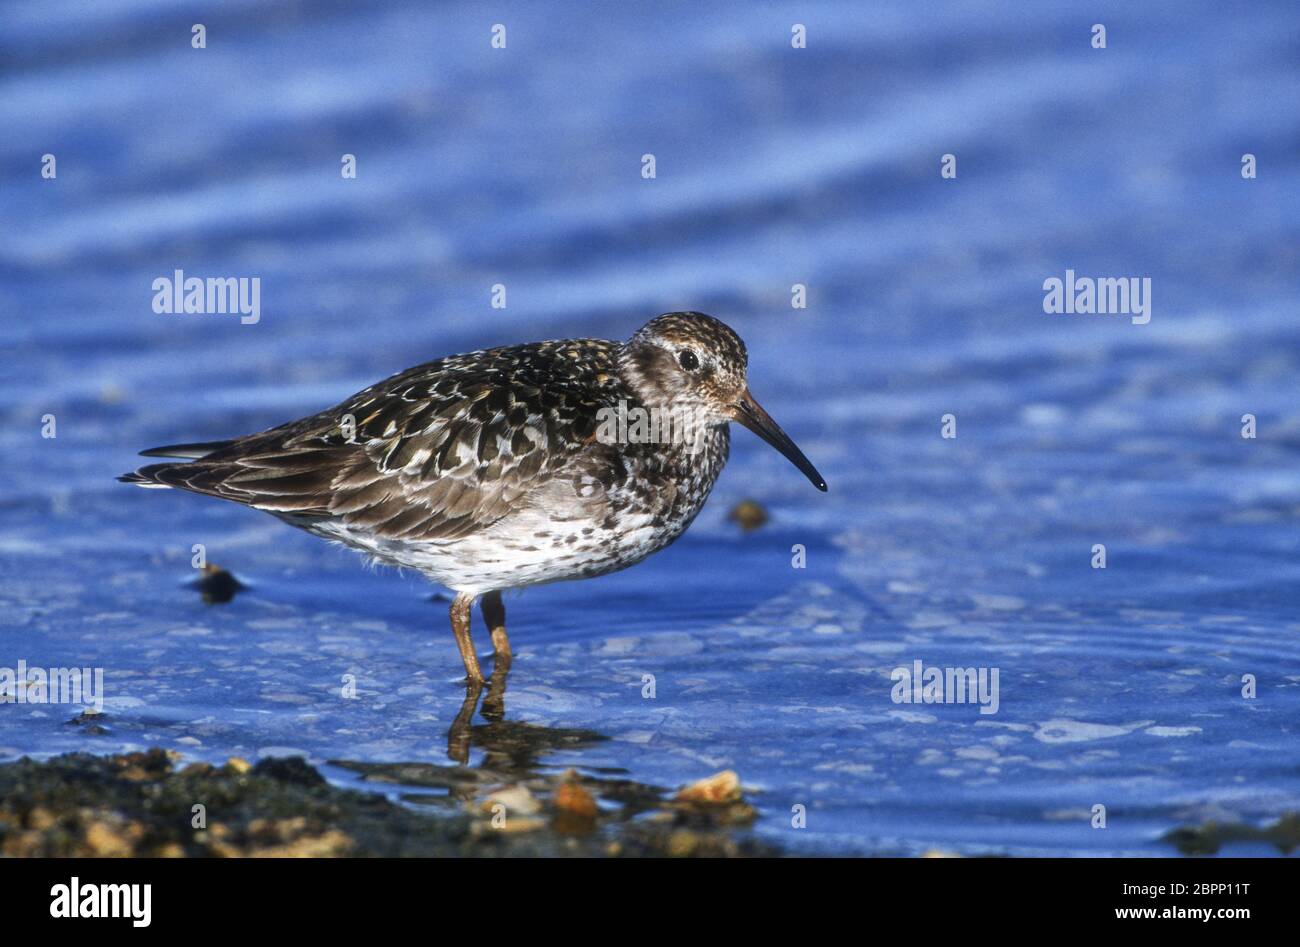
[0,0,1300,855]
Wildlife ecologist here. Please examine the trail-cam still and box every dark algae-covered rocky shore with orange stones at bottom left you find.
[0,749,780,857]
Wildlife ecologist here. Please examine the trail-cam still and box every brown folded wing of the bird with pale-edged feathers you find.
[124,340,620,539]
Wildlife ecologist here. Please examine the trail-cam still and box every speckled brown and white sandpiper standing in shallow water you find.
[118,312,827,686]
